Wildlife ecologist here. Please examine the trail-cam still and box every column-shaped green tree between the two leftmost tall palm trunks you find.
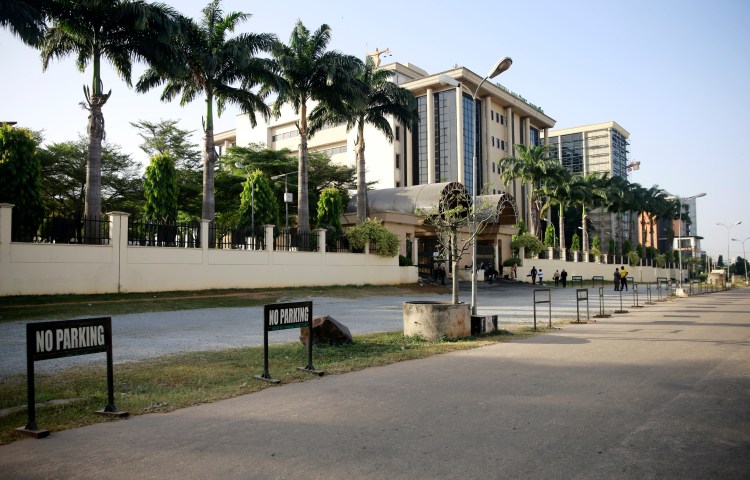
[143,153,177,223]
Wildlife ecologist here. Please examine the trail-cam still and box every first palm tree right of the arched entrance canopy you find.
[500,144,560,236]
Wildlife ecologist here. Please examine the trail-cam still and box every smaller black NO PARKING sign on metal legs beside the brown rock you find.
[254,301,325,383]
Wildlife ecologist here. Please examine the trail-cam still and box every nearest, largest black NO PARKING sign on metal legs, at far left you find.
[16,317,128,438]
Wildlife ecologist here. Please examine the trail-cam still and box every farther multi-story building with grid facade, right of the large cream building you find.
[545,122,634,252]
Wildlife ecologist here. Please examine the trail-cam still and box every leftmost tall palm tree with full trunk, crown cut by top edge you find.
[42,0,177,216]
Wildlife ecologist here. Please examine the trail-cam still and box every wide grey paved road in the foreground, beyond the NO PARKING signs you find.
[0,289,750,480]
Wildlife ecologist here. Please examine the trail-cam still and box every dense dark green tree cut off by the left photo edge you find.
[0,124,44,232]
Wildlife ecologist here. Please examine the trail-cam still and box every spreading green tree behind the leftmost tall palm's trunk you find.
[39,137,144,220]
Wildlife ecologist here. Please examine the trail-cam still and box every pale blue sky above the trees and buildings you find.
[0,0,750,259]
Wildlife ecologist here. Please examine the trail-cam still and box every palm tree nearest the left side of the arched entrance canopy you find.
[310,57,419,225]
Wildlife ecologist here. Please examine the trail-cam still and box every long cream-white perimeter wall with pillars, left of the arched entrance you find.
[0,204,417,295]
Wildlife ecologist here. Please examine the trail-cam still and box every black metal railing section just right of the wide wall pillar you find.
[128,220,201,248]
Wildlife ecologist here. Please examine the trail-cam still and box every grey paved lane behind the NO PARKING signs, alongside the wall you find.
[0,282,633,379]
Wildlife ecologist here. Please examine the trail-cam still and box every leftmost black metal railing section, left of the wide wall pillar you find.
[11,214,109,245]
